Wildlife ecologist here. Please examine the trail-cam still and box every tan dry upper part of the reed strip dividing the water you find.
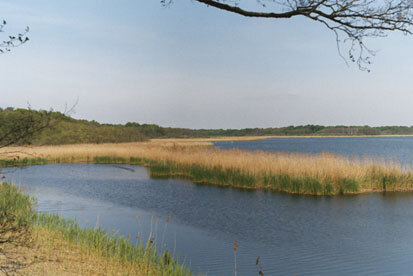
[0,139,413,192]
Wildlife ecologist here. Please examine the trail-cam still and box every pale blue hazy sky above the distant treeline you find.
[0,0,413,128]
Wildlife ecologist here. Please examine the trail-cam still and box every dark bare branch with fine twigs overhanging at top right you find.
[173,0,413,71]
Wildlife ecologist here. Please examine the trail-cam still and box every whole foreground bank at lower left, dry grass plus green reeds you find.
[0,183,196,275]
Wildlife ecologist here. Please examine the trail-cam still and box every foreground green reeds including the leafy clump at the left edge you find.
[0,183,198,276]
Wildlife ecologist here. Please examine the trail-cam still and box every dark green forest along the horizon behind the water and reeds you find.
[0,107,413,145]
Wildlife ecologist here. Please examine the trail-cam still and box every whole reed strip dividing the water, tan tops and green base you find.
[0,139,413,195]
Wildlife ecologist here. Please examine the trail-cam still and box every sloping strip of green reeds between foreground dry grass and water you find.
[33,213,192,276]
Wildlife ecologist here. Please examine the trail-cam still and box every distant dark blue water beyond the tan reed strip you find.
[214,137,413,166]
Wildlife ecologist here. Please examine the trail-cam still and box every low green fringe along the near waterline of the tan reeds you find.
[0,156,413,196]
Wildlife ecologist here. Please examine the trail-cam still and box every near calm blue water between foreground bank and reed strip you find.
[5,164,413,275]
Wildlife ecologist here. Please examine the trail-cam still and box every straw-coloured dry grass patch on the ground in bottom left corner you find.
[0,226,166,276]
